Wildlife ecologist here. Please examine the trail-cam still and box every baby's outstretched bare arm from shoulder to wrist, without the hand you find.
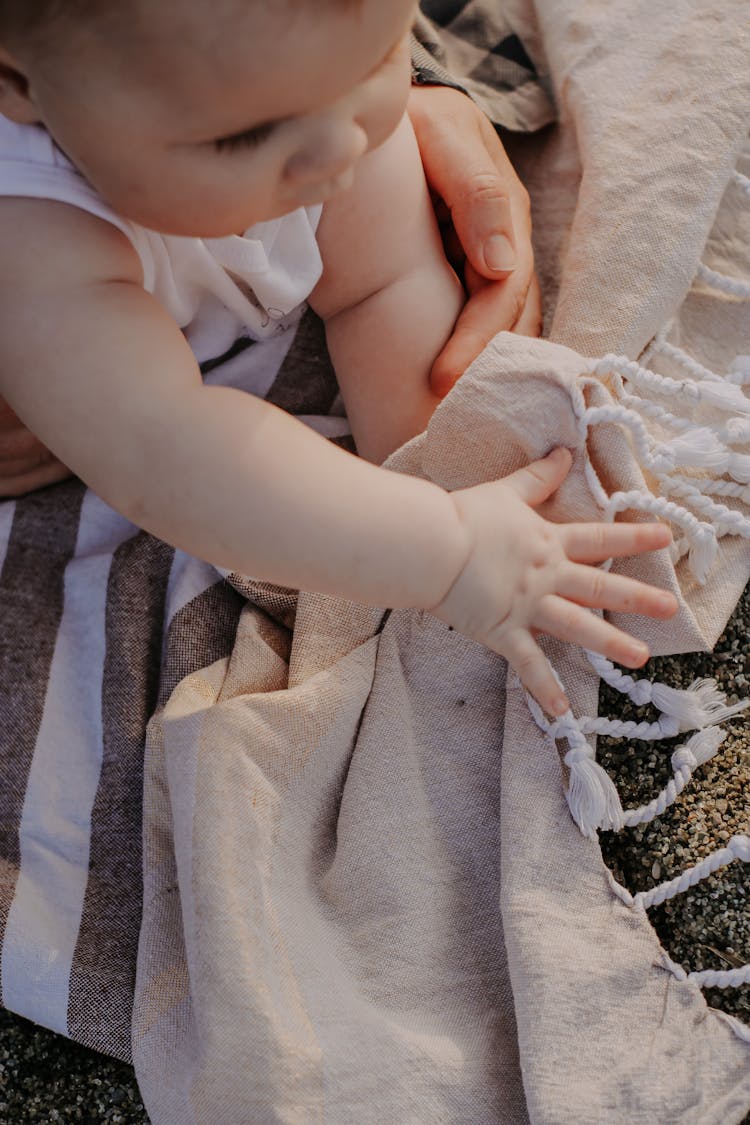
[0,198,466,606]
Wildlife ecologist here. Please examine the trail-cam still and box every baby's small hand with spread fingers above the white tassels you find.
[432,449,677,716]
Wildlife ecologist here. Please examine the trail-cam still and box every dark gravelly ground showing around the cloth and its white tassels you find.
[0,587,750,1125]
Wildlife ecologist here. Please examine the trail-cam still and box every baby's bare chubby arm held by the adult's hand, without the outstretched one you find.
[310,117,466,464]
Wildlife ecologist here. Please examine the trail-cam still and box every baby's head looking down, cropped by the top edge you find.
[0,0,415,237]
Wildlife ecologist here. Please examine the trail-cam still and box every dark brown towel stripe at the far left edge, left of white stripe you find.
[0,480,85,1002]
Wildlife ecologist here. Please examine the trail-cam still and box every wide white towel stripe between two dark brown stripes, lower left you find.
[1,493,134,1035]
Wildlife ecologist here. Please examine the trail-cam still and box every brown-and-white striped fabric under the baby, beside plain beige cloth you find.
[0,312,350,1060]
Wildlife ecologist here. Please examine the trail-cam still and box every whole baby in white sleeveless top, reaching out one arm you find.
[0,0,676,714]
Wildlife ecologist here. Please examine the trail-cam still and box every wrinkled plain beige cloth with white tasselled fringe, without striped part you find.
[134,0,750,1125]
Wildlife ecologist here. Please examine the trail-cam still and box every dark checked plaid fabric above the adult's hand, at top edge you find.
[412,0,555,133]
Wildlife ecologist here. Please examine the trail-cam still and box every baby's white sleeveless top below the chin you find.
[0,115,323,360]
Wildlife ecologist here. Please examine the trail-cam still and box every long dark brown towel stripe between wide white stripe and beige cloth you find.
[67,531,174,1060]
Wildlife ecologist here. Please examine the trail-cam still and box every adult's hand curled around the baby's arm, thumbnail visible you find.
[408,86,542,396]
